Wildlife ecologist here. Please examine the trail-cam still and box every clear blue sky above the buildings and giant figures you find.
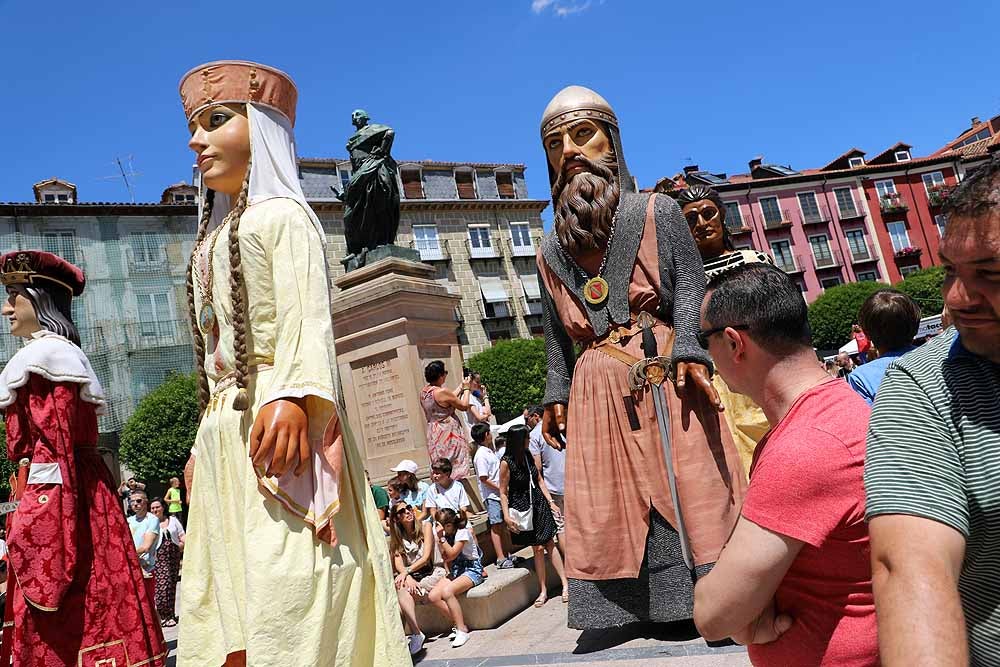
[0,0,1000,218]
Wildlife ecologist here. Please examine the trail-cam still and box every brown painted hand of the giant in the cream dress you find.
[250,398,310,477]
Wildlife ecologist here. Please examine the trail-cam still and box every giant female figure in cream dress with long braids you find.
[178,61,409,667]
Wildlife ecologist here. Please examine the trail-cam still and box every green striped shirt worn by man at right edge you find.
[865,328,1000,665]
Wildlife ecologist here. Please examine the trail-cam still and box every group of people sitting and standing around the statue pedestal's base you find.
[369,361,569,655]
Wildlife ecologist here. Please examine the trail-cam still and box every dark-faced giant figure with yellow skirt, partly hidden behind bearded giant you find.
[677,185,772,475]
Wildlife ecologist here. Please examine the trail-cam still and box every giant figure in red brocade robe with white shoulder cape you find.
[0,251,167,667]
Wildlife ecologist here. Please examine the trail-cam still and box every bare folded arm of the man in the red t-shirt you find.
[694,516,804,641]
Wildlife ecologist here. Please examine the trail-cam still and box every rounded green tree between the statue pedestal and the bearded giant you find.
[468,338,547,423]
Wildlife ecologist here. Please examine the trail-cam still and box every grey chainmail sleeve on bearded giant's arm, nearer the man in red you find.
[655,195,713,373]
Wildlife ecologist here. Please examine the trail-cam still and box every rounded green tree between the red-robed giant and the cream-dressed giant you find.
[119,373,198,482]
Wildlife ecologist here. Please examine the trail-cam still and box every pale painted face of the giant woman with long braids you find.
[188,104,250,197]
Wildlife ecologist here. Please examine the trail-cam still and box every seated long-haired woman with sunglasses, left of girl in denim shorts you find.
[389,500,450,655]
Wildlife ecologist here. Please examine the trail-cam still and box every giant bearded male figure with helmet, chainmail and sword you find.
[538,86,744,630]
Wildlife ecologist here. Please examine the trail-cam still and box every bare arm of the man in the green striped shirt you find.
[868,514,969,667]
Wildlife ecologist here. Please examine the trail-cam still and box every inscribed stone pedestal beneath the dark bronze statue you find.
[332,256,471,483]
